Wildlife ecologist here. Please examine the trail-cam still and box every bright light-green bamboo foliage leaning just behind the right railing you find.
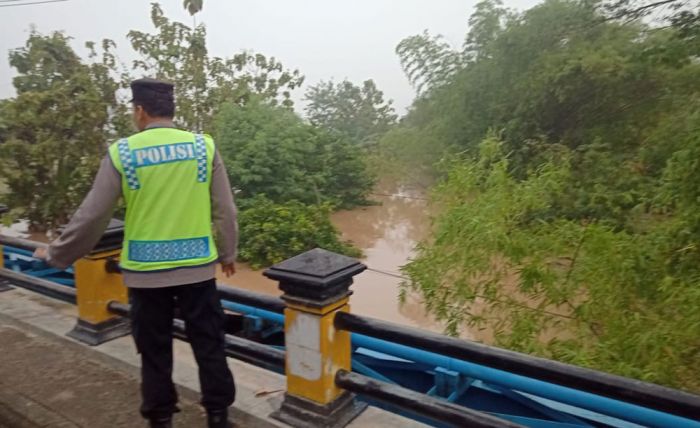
[404,136,700,390]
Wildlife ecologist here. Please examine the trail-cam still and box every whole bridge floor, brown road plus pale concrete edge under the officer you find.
[0,289,424,428]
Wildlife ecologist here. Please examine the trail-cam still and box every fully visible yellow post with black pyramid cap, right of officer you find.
[264,248,367,427]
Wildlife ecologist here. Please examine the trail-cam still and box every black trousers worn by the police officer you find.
[129,279,236,418]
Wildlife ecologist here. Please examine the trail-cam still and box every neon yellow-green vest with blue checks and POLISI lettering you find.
[109,128,218,272]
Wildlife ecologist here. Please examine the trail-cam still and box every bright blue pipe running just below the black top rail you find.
[223,301,700,428]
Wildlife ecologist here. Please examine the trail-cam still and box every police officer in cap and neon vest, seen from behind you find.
[35,79,238,428]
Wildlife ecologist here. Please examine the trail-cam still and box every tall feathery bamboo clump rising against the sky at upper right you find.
[392,0,700,222]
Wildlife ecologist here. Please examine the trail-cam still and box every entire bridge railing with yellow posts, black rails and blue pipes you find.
[0,235,700,427]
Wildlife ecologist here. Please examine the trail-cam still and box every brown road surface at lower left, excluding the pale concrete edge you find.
[0,315,203,428]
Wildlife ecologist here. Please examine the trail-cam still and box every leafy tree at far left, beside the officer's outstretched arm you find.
[0,31,127,230]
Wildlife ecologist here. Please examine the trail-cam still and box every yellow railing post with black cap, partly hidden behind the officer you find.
[68,221,130,346]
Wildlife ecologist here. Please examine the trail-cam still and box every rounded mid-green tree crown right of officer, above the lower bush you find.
[215,99,373,207]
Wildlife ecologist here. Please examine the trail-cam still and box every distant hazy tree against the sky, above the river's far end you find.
[304,80,396,146]
